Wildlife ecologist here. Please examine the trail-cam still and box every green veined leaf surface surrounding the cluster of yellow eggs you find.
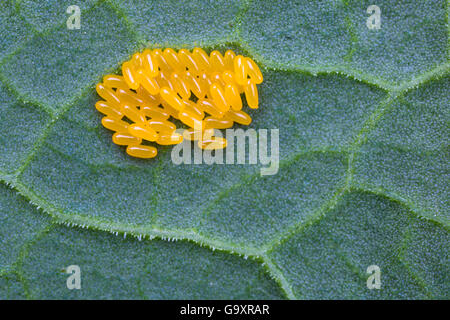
[0,0,450,299]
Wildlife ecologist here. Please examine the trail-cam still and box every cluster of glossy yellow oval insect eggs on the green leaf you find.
[95,48,263,158]
